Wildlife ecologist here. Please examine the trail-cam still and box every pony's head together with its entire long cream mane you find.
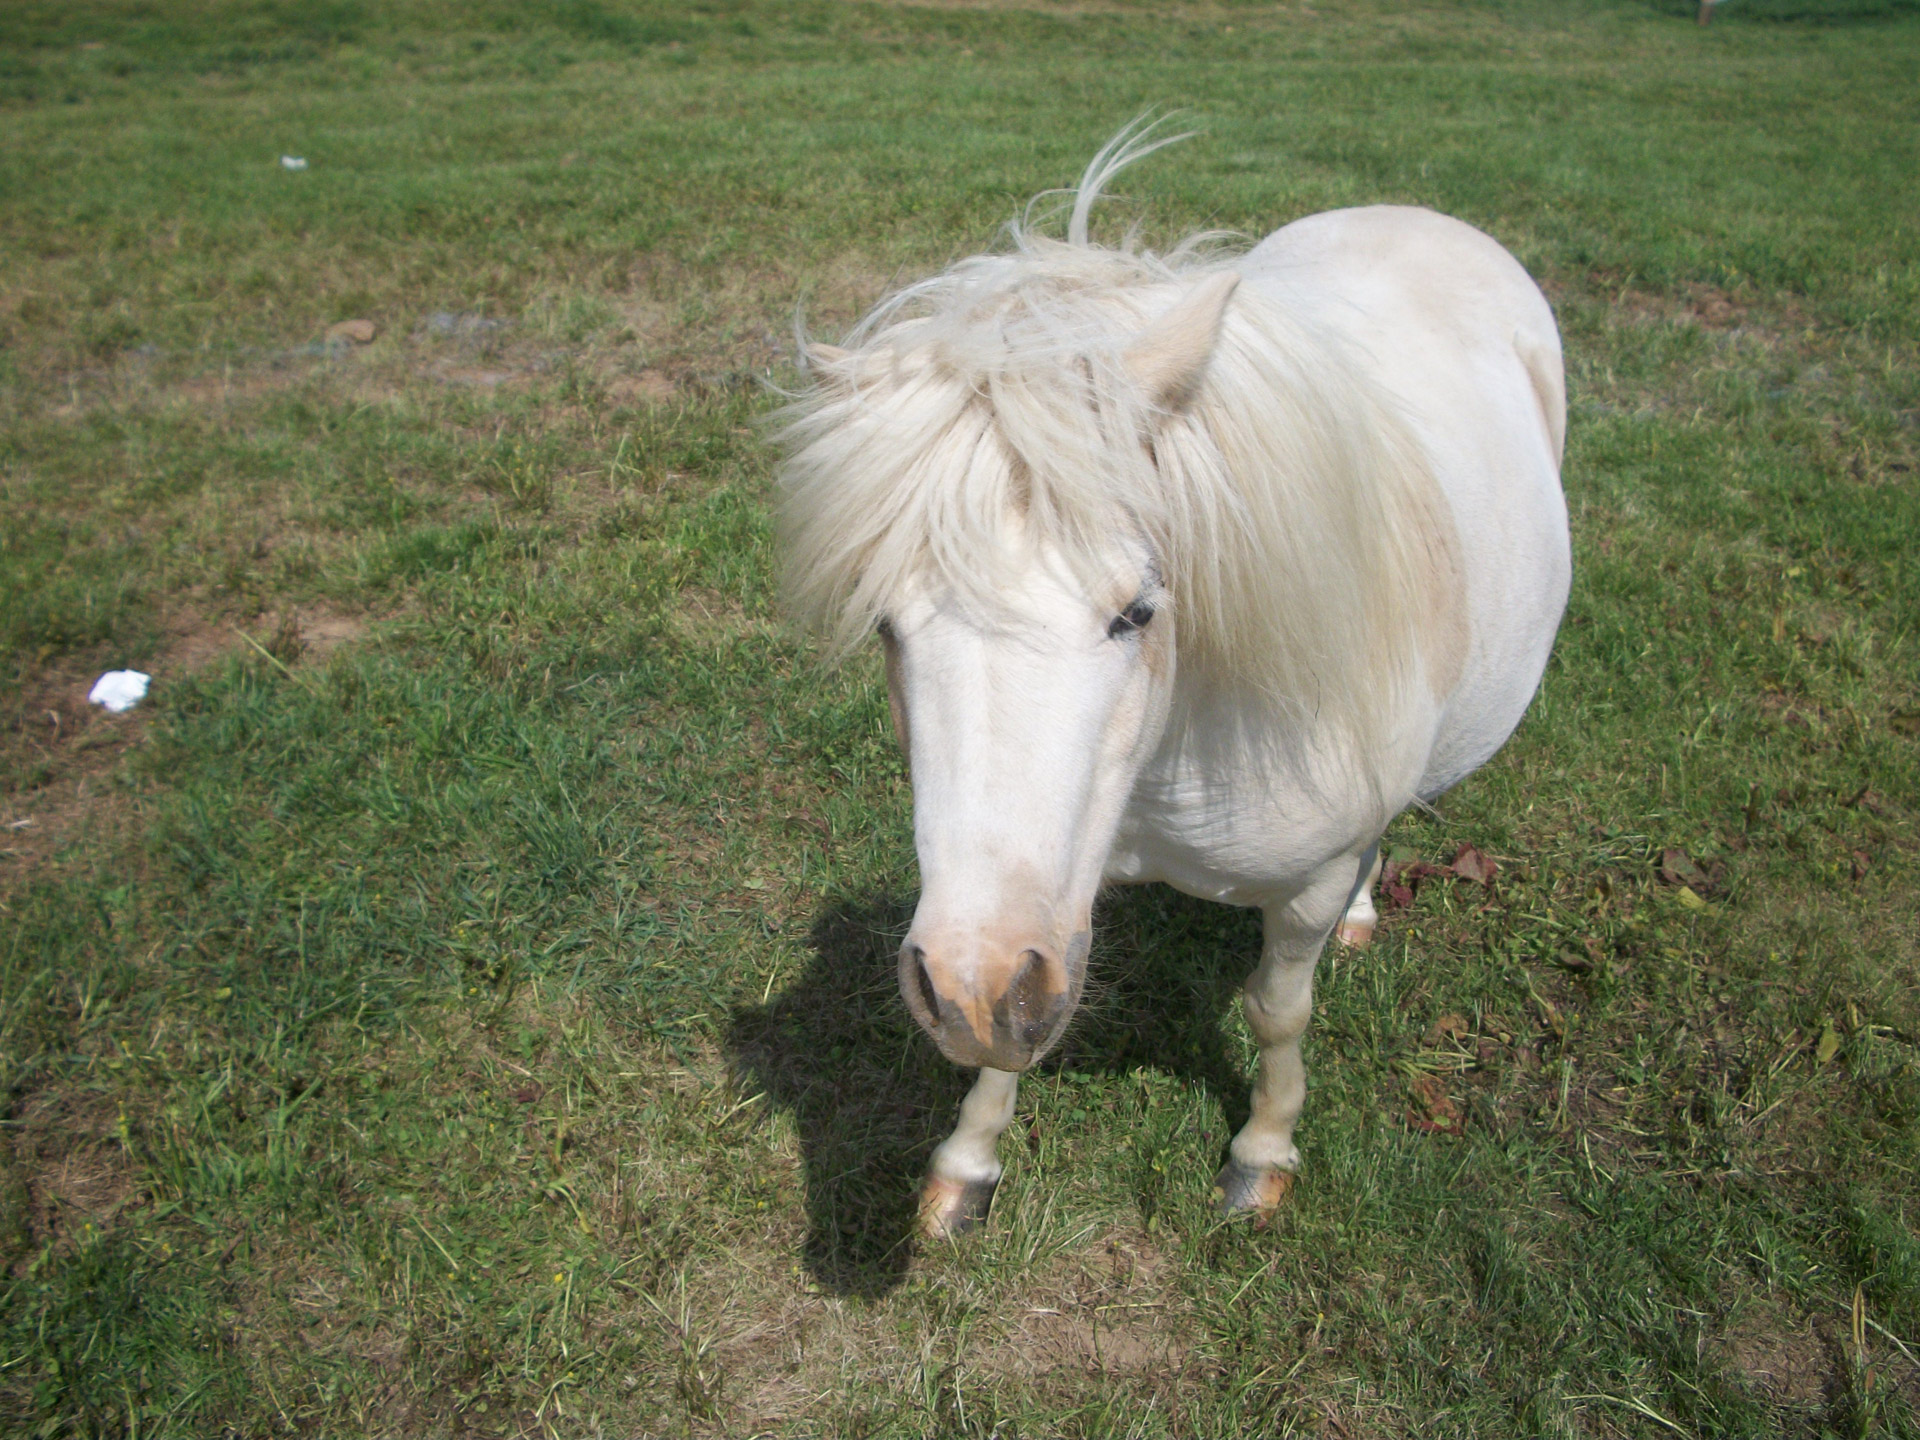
[780,129,1443,1069]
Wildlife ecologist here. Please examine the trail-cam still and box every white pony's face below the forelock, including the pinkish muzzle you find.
[881,538,1175,1069]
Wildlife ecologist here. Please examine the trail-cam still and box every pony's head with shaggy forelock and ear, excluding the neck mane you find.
[785,245,1238,1069]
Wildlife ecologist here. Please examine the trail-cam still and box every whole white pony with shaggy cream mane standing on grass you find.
[780,127,1569,1235]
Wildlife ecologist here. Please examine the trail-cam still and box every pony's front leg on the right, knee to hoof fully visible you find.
[1213,854,1373,1212]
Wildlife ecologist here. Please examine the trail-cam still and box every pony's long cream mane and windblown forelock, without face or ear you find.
[780,127,1453,779]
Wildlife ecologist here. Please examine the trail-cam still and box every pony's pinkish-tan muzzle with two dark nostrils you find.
[900,931,1089,1071]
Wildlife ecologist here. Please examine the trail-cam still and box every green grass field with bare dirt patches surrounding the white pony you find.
[0,0,1920,1440]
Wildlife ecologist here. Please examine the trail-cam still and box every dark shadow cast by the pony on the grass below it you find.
[728,885,1260,1298]
